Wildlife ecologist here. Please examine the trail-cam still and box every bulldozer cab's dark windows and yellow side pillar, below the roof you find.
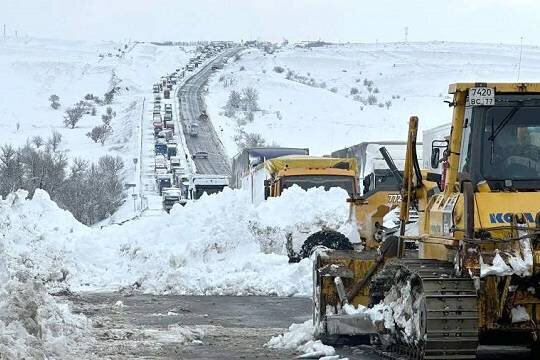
[458,94,540,191]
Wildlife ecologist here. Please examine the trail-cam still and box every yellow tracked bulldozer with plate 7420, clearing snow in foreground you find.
[313,83,540,359]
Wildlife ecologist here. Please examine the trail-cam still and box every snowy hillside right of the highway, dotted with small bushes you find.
[207,42,540,157]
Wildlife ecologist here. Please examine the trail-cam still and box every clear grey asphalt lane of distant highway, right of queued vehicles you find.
[178,49,240,175]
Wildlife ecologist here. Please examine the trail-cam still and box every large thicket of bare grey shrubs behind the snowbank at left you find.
[0,145,125,224]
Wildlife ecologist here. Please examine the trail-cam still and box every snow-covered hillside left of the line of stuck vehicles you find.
[0,39,193,174]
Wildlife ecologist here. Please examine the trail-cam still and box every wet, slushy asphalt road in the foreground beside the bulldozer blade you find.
[65,293,311,360]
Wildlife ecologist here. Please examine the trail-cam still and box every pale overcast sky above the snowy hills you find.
[4,0,540,45]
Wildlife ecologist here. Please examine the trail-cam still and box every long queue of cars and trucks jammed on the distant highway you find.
[152,43,230,212]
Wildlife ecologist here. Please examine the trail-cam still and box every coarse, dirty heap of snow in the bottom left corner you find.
[0,248,93,360]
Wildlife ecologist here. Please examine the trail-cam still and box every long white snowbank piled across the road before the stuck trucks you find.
[0,187,348,296]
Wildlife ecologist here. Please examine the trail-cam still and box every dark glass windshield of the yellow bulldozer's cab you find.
[482,106,540,180]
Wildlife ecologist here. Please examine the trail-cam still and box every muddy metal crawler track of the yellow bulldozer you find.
[371,259,478,360]
